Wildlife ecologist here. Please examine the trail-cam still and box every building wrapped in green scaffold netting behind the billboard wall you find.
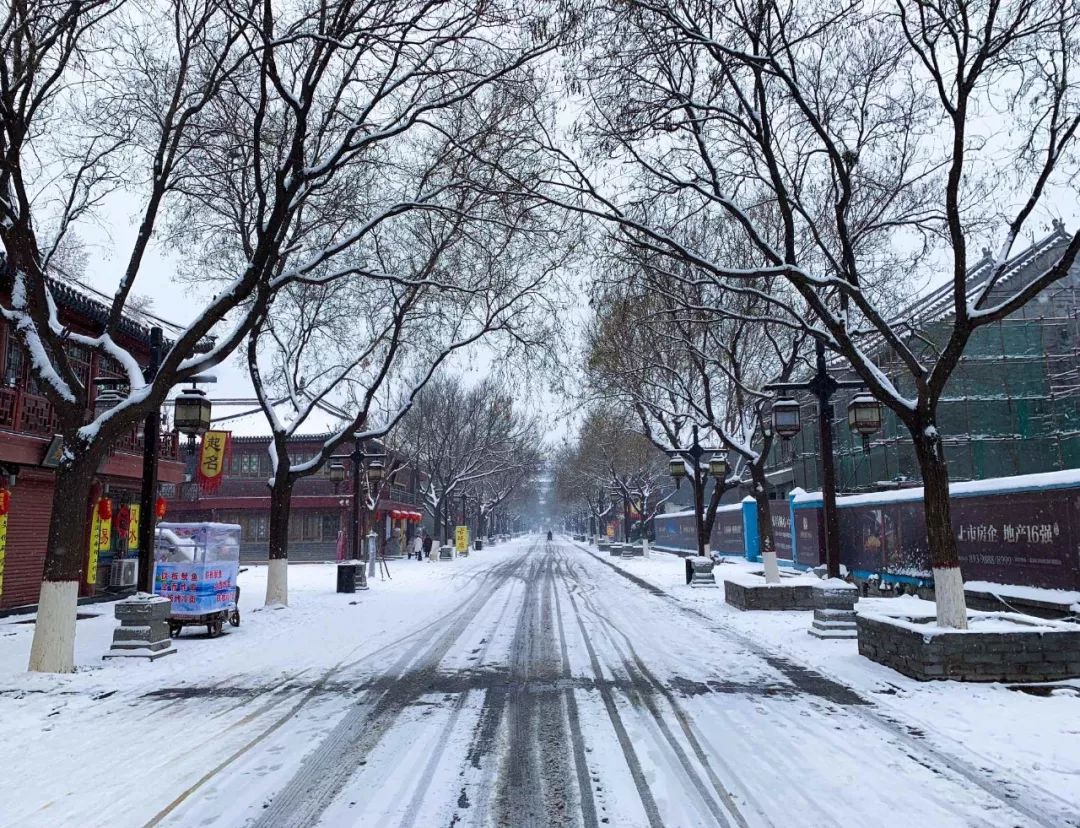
[768,223,1080,498]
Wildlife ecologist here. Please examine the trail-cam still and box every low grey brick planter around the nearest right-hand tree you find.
[856,611,1080,682]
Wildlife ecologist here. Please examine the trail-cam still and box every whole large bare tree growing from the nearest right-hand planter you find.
[522,0,1080,627]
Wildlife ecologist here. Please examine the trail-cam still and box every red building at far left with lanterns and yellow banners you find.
[0,256,184,610]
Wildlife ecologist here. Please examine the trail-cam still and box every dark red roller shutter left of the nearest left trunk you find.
[0,474,53,607]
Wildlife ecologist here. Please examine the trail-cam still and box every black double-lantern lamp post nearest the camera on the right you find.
[765,339,881,578]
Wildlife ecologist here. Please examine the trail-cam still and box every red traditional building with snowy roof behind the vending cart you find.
[167,427,423,561]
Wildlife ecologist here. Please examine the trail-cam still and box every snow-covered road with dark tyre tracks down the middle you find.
[0,538,1069,828]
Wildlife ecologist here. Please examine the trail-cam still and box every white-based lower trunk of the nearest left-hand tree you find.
[29,453,98,673]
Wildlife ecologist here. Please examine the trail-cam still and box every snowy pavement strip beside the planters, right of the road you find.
[591,547,1080,812]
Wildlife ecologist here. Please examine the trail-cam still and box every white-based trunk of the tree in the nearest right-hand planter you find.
[912,418,968,629]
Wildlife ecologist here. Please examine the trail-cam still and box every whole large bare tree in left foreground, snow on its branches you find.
[0,0,552,671]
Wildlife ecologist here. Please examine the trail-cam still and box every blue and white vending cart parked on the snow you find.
[153,524,240,638]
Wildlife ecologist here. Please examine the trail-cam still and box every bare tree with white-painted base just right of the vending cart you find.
[247,181,558,605]
